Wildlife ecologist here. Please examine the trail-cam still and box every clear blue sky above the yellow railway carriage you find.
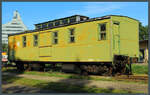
[2,2,148,30]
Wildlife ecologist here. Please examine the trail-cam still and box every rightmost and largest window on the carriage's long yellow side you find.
[99,24,106,40]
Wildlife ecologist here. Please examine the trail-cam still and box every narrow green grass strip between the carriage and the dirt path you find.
[3,67,147,84]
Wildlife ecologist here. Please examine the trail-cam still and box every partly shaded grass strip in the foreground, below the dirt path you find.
[2,76,142,93]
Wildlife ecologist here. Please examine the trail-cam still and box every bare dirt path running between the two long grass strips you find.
[3,73,148,93]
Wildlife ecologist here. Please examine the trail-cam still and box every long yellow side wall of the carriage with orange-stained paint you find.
[7,19,112,62]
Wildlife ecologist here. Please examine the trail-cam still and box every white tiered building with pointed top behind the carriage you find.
[2,11,27,44]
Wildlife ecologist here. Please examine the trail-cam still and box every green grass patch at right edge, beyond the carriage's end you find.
[132,64,148,75]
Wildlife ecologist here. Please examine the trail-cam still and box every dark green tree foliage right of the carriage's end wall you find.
[139,23,148,40]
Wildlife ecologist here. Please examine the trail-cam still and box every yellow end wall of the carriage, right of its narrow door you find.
[112,16,139,57]
